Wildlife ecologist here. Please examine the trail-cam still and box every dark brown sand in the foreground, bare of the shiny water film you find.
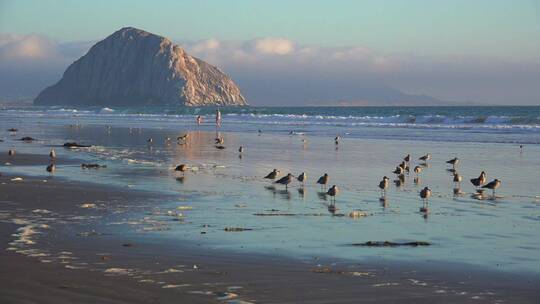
[0,153,540,303]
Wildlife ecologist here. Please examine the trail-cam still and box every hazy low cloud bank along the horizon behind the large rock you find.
[0,34,540,105]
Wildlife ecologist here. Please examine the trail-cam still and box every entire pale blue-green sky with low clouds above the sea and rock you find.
[0,0,540,105]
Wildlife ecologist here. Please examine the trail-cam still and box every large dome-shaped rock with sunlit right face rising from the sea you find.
[34,27,247,106]
